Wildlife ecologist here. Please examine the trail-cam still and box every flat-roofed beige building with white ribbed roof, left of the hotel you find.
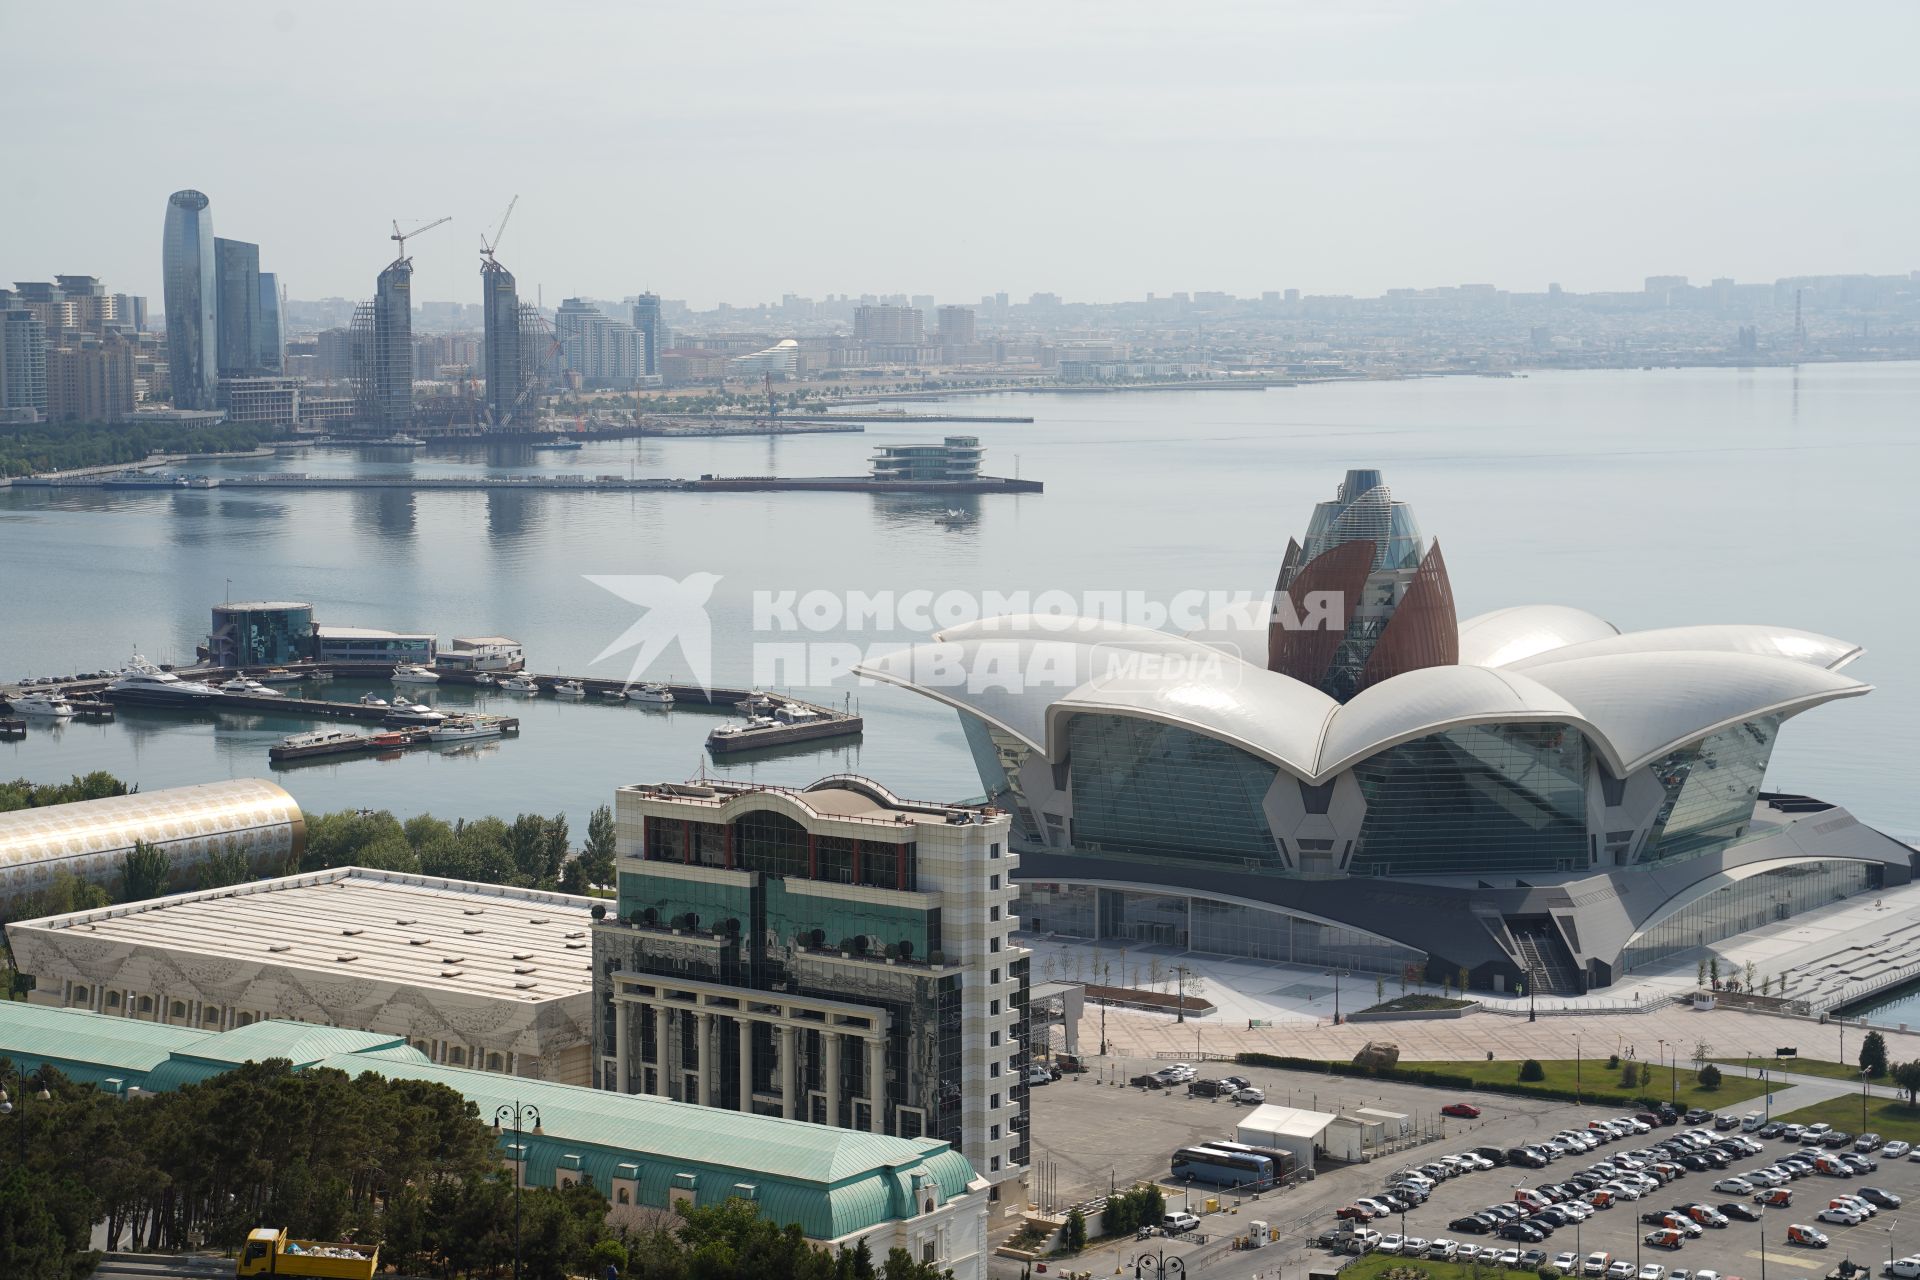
[8,867,593,1084]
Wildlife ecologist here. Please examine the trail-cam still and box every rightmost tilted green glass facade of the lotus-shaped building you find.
[1642,716,1780,862]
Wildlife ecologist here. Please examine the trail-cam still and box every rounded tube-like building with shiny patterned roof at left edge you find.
[0,777,307,929]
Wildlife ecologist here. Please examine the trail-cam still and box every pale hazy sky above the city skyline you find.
[0,0,1920,307]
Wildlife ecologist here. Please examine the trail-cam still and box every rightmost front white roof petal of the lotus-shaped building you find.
[1520,652,1872,775]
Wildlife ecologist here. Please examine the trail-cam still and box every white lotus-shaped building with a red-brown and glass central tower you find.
[864,470,1910,992]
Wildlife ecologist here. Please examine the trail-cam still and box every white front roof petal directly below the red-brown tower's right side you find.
[1315,666,1594,775]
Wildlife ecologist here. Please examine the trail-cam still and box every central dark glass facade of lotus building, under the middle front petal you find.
[1350,723,1588,875]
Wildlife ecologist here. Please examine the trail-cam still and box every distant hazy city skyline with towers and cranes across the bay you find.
[0,190,1920,436]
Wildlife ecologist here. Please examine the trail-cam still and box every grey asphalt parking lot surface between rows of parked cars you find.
[1033,1067,1920,1280]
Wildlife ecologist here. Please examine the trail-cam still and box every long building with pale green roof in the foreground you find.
[0,1002,987,1280]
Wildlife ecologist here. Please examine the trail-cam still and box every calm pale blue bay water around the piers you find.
[0,365,1920,839]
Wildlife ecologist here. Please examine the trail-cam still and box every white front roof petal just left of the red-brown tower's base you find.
[1046,649,1340,777]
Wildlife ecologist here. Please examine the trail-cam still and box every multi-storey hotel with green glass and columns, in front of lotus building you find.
[593,775,1027,1203]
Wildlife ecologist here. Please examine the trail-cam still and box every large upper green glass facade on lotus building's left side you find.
[1068,716,1284,869]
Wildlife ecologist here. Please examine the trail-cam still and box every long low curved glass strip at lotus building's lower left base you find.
[1020,883,1427,975]
